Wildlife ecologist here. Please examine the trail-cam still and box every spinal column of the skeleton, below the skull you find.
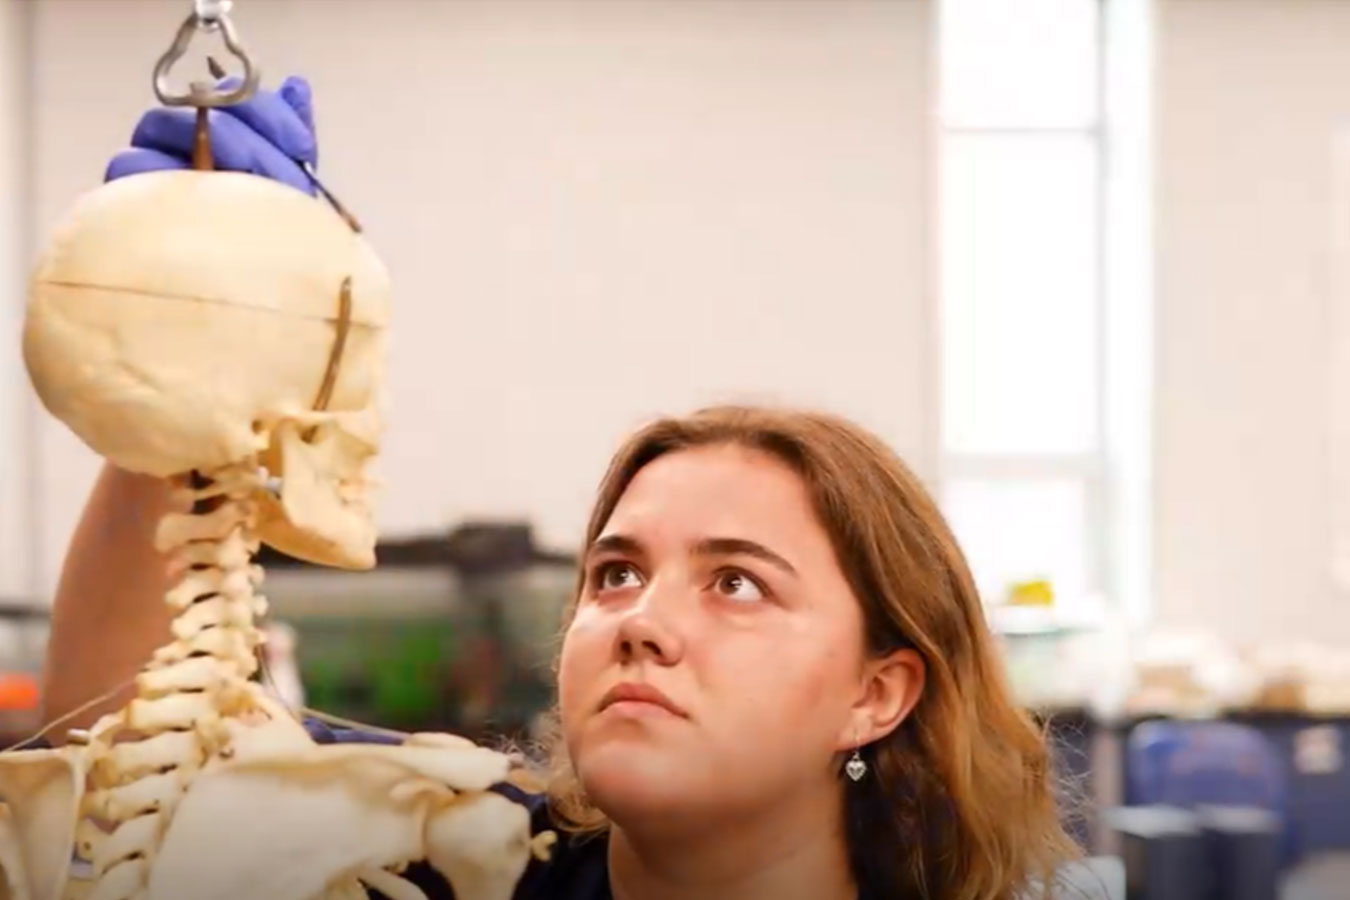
[81,463,274,900]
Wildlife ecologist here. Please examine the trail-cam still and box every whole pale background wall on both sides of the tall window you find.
[18,0,1350,640]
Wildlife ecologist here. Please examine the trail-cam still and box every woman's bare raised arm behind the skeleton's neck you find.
[42,466,179,743]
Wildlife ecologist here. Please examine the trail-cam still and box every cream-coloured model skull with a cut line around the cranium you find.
[23,170,390,568]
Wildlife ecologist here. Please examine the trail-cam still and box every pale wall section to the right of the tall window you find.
[1154,0,1350,641]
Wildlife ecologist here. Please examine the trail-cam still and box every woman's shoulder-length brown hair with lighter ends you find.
[531,406,1079,900]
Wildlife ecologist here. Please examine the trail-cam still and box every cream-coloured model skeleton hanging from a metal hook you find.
[0,0,551,900]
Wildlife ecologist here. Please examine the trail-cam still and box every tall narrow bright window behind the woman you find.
[936,0,1146,626]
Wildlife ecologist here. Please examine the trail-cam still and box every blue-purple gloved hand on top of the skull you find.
[104,76,319,196]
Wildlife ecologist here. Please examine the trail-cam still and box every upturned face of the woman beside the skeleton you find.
[559,445,909,826]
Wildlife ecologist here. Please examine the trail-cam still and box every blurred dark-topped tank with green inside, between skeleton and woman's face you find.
[253,524,574,739]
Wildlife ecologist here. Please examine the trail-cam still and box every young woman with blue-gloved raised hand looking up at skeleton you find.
[46,80,1075,900]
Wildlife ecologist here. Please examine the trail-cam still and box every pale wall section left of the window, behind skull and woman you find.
[15,0,932,601]
